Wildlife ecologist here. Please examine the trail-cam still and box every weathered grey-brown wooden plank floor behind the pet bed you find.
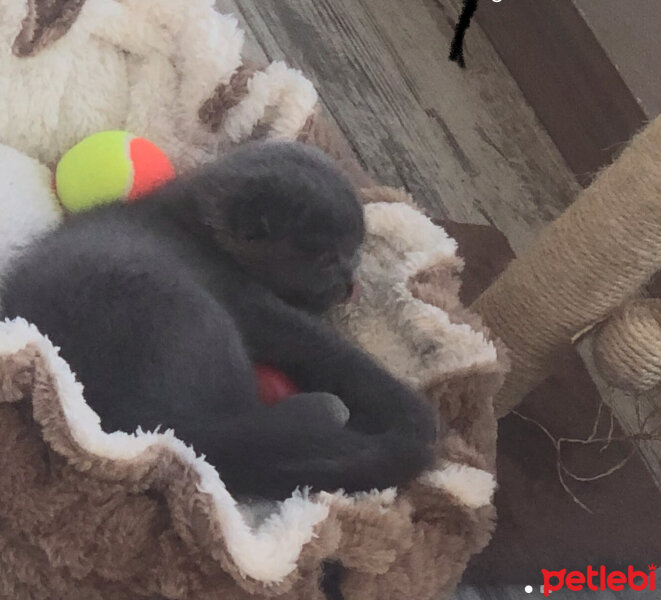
[216,0,651,600]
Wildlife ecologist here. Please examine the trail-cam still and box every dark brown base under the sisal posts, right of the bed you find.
[441,222,661,584]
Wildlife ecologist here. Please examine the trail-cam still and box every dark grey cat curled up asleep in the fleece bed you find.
[5,142,437,499]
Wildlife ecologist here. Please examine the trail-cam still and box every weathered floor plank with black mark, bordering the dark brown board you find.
[363,0,576,250]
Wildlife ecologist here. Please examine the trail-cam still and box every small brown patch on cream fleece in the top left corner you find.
[12,0,85,57]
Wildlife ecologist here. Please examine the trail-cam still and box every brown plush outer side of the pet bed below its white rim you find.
[0,292,503,600]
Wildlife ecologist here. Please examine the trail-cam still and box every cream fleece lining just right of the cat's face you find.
[332,202,498,388]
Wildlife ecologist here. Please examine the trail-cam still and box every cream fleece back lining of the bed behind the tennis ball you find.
[0,0,317,172]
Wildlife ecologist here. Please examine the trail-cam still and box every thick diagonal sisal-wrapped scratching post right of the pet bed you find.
[474,118,661,416]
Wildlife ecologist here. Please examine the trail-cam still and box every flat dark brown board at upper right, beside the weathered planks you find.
[467,0,646,184]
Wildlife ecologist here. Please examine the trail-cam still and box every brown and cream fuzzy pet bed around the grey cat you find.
[0,0,504,600]
